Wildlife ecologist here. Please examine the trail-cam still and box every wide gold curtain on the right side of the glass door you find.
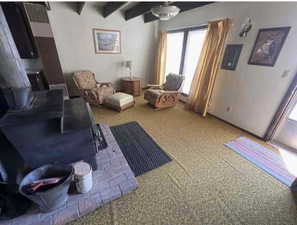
[186,19,231,116]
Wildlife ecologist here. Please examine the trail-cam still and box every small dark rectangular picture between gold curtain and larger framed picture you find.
[221,44,243,70]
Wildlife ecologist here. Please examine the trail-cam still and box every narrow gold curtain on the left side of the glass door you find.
[155,32,167,85]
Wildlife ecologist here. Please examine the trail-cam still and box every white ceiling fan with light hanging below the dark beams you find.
[151,2,180,20]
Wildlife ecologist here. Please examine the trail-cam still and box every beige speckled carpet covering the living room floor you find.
[71,97,297,225]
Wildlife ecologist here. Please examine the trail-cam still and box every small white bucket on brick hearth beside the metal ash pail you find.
[73,162,93,193]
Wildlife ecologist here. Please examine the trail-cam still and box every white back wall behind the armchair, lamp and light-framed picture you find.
[48,2,158,96]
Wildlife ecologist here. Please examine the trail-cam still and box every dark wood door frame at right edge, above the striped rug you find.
[264,74,297,141]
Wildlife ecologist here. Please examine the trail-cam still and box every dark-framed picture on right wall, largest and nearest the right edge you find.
[248,27,290,66]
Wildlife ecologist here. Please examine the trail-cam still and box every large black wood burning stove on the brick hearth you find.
[0,90,107,180]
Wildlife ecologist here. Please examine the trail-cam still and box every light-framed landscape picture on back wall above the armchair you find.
[93,29,121,54]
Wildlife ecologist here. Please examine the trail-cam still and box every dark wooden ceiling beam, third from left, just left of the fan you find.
[125,2,163,20]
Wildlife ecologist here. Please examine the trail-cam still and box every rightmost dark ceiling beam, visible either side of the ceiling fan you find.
[143,2,214,23]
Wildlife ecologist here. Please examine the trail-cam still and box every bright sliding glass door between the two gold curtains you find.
[166,27,207,95]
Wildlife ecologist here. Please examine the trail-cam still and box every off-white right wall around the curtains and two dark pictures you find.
[160,2,297,136]
